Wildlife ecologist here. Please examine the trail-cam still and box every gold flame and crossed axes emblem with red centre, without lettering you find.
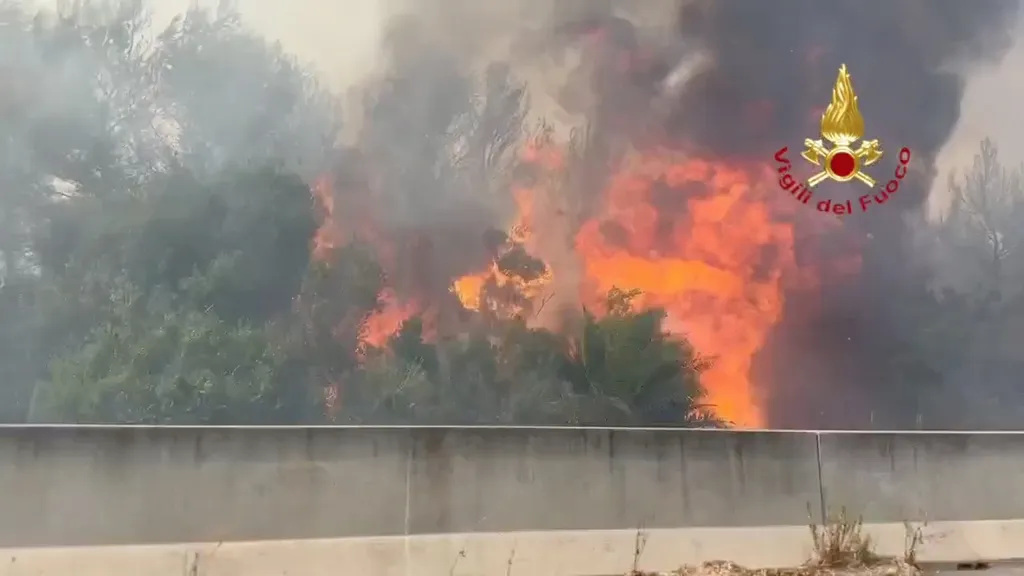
[801,64,883,188]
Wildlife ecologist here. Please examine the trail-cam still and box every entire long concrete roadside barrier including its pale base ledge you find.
[0,426,1024,576]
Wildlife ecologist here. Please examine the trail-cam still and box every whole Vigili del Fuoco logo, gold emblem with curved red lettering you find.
[775,65,910,216]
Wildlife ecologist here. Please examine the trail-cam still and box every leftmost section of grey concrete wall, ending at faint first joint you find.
[0,426,414,546]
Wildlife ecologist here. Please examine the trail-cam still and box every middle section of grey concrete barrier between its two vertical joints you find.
[403,428,821,534]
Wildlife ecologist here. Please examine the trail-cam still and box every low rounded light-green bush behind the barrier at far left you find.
[34,272,296,424]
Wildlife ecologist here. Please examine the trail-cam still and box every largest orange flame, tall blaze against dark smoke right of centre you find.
[577,152,796,427]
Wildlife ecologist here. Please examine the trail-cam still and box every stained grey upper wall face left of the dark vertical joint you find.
[0,427,820,546]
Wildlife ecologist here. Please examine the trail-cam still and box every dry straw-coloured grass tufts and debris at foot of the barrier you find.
[629,508,922,576]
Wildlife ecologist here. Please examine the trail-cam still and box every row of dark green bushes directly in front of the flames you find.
[329,291,723,426]
